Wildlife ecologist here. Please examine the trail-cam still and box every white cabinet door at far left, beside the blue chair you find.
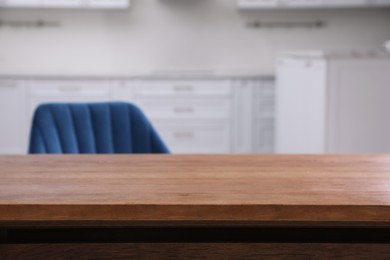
[0,79,28,154]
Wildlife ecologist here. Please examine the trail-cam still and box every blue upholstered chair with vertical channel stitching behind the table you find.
[29,102,169,154]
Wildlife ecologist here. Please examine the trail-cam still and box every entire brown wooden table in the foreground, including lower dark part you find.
[0,155,390,259]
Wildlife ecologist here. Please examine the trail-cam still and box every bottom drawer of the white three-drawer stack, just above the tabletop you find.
[155,124,231,153]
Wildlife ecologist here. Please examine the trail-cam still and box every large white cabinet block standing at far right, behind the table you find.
[276,53,390,153]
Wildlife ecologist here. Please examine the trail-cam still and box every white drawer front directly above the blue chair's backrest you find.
[30,80,111,97]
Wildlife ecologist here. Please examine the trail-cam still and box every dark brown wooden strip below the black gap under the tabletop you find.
[0,243,390,260]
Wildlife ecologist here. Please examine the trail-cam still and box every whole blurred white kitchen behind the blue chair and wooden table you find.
[0,0,390,154]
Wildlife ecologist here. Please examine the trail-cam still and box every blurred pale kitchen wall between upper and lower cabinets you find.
[0,0,390,75]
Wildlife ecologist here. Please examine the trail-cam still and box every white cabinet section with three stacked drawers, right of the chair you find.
[135,79,233,153]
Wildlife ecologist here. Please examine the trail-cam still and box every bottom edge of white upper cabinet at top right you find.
[238,0,390,9]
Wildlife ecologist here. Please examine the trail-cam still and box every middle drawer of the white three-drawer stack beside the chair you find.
[137,99,231,119]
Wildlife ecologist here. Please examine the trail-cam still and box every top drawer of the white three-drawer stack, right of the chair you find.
[136,80,231,97]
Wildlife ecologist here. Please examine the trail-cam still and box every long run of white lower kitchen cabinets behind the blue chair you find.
[0,77,274,153]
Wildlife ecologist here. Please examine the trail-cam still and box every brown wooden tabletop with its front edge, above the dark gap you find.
[0,155,390,223]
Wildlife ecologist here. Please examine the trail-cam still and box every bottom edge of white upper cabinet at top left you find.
[0,0,130,9]
